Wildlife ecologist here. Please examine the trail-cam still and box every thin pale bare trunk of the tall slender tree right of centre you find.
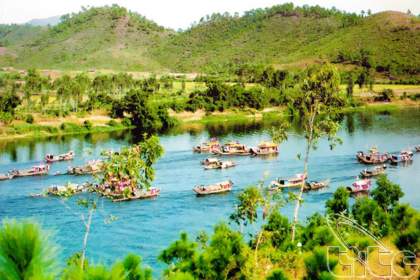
[292,110,316,242]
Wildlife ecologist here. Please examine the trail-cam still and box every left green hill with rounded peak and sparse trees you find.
[0,5,171,70]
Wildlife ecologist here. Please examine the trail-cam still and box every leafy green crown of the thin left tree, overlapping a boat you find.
[102,136,163,189]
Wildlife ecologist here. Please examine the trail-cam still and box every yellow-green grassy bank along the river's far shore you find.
[0,101,420,141]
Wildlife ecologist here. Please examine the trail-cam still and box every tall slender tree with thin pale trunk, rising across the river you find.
[292,64,344,241]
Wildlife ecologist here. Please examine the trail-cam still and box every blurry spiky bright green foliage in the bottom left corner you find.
[0,220,57,280]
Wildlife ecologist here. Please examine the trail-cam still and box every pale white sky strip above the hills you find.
[0,0,420,29]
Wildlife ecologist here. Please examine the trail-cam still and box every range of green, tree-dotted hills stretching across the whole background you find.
[0,4,420,74]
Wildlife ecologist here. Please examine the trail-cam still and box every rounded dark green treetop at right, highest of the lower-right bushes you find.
[371,175,404,212]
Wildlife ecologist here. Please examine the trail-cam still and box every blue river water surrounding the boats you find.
[0,110,420,271]
